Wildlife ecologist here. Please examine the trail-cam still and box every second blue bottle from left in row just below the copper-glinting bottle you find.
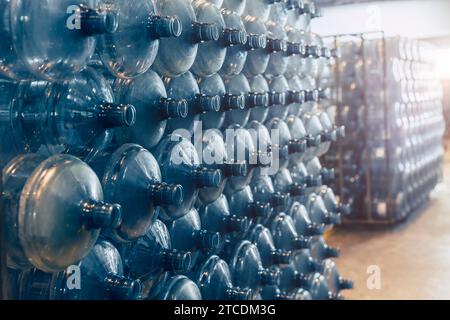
[119,220,191,299]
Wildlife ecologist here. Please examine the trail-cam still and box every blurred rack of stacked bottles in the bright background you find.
[325,34,445,223]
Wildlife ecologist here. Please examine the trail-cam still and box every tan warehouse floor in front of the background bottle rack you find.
[328,149,450,300]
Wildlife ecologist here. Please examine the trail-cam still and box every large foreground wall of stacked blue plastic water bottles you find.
[0,0,352,300]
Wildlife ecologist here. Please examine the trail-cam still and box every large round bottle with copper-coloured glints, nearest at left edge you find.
[2,154,121,272]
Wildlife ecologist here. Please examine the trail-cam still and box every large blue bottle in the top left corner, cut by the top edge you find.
[0,0,119,81]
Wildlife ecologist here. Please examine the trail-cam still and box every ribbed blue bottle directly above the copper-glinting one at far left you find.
[4,69,136,160]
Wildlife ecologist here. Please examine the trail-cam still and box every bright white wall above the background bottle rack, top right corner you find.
[313,0,450,38]
